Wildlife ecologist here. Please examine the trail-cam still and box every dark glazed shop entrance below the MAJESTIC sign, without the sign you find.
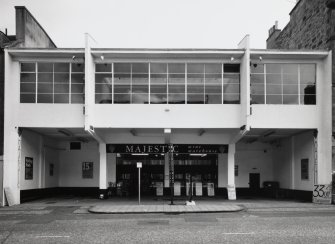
[116,153,218,196]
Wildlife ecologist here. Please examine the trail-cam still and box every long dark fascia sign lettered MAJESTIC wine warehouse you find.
[106,144,228,154]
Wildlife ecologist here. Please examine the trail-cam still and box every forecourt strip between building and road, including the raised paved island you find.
[9,196,335,214]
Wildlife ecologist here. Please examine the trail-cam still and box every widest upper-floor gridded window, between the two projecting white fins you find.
[95,63,240,104]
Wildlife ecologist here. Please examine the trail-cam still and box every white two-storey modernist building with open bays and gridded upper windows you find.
[4,35,332,204]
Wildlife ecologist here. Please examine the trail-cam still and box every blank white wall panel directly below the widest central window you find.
[93,104,241,128]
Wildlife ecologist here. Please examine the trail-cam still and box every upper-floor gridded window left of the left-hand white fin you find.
[20,62,85,103]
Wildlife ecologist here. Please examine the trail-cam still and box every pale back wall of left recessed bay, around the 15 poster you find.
[59,142,100,187]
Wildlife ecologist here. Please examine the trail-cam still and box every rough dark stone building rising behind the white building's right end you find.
[266,0,335,169]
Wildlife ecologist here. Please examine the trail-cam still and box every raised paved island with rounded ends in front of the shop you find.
[88,204,244,214]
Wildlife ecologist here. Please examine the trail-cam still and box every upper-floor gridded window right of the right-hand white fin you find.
[250,64,316,104]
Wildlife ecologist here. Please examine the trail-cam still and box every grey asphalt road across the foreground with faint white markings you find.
[0,206,335,244]
